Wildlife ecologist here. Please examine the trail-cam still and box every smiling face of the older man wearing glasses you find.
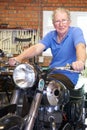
[53,11,70,34]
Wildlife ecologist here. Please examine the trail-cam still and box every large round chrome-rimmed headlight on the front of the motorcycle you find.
[13,64,36,89]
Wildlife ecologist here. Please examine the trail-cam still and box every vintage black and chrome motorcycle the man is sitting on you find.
[0,63,87,130]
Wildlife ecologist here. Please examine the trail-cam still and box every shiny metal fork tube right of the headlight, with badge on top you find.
[24,79,45,130]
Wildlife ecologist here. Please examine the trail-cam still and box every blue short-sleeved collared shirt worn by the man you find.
[40,27,86,84]
